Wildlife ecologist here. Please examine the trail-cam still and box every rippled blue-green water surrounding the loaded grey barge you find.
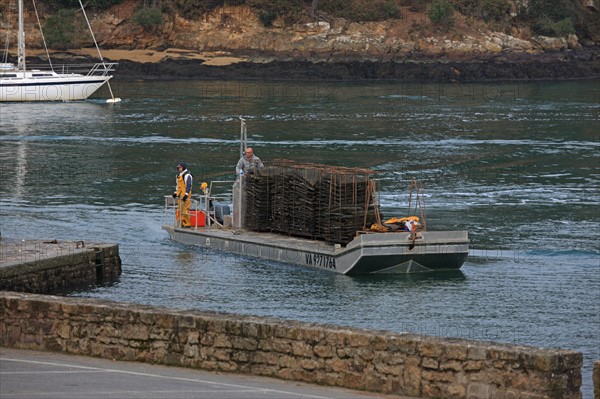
[0,82,600,397]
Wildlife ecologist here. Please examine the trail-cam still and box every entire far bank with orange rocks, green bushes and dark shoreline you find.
[0,0,600,83]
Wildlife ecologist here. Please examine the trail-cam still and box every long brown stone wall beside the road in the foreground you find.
[0,292,583,399]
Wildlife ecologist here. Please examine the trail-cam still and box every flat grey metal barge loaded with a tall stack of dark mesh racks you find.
[163,120,469,275]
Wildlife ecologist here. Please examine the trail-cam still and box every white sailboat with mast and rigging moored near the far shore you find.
[0,0,120,102]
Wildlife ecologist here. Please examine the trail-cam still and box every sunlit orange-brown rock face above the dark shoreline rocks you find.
[85,0,592,59]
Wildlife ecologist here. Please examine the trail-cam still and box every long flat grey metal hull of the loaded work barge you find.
[163,225,469,275]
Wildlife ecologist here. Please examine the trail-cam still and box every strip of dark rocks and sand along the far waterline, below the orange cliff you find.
[15,47,600,83]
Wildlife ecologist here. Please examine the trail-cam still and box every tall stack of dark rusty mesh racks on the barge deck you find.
[244,160,381,245]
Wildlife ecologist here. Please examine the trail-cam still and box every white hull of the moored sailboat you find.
[0,75,110,102]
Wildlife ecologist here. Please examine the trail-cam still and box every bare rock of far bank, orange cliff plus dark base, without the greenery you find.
[0,0,600,82]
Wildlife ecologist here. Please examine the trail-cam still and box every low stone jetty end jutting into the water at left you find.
[0,239,121,294]
